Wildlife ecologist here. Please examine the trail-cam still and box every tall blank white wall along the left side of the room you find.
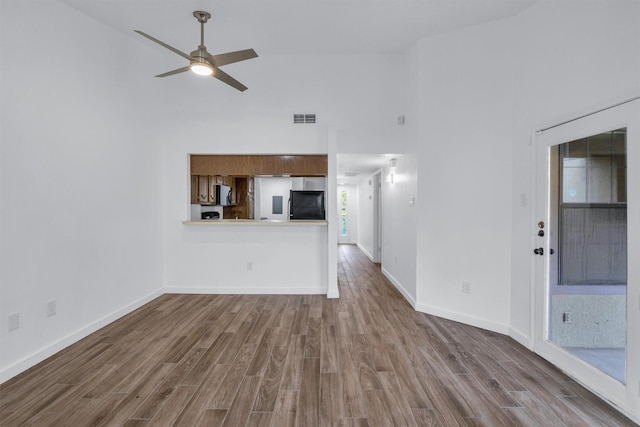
[0,1,163,382]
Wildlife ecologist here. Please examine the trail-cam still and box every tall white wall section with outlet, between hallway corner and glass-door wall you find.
[409,17,513,332]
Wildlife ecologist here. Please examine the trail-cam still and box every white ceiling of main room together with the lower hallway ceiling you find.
[60,0,537,185]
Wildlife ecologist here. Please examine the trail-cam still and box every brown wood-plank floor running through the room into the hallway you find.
[0,246,635,427]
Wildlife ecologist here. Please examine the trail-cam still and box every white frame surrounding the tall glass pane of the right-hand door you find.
[531,100,640,421]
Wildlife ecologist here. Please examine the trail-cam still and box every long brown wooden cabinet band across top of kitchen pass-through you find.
[191,154,327,176]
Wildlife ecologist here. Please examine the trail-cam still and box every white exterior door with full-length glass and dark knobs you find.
[531,101,640,418]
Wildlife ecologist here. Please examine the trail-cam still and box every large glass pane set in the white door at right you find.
[548,129,627,383]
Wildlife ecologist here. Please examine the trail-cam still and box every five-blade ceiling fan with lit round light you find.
[133,10,258,92]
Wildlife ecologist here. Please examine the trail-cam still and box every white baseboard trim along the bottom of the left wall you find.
[0,289,164,384]
